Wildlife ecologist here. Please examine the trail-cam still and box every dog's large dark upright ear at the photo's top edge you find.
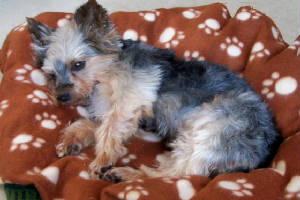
[74,0,120,53]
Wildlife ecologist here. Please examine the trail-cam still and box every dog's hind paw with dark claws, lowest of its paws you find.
[102,167,145,183]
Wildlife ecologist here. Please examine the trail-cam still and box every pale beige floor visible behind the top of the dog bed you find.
[0,0,300,200]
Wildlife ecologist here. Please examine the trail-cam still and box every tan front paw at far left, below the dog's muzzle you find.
[56,133,82,158]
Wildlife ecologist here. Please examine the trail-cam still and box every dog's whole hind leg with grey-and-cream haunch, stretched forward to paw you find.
[103,93,276,180]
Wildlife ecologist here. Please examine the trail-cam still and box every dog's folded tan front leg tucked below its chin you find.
[56,119,97,157]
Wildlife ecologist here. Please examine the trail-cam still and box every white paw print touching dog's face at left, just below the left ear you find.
[15,64,47,86]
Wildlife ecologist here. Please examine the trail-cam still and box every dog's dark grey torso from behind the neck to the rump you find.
[121,41,278,176]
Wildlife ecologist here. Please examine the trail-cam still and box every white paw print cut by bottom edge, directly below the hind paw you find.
[118,185,149,200]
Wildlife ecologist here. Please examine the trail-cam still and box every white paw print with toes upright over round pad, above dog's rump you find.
[220,36,244,57]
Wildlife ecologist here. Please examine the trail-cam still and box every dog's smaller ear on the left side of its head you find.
[27,18,54,67]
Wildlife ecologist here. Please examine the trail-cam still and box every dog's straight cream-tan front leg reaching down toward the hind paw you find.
[90,106,140,178]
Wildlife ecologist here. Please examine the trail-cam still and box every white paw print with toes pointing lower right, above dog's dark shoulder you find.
[159,27,185,48]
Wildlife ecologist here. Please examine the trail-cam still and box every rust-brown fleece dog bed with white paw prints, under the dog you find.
[0,3,300,200]
